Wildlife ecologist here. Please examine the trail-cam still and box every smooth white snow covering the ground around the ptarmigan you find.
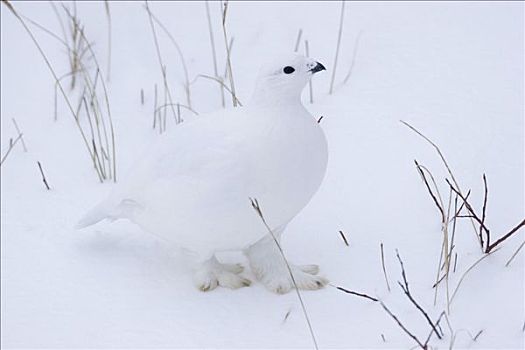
[1,2,525,349]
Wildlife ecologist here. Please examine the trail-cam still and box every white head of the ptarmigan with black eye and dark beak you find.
[252,54,326,105]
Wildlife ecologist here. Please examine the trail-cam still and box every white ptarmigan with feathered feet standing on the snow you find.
[77,55,328,293]
